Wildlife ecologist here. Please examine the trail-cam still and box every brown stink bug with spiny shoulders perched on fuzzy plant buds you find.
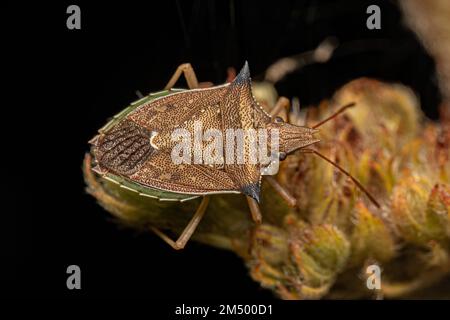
[86,63,379,249]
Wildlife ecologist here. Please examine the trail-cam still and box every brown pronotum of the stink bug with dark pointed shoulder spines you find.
[220,63,270,202]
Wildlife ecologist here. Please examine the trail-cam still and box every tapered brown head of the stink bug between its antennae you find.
[269,117,320,160]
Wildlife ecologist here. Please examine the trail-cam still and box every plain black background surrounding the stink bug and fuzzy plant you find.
[7,0,440,301]
